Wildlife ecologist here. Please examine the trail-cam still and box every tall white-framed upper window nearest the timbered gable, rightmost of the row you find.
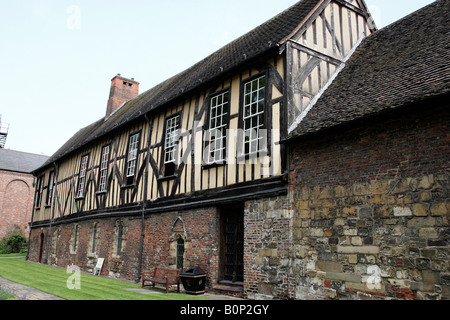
[243,76,266,154]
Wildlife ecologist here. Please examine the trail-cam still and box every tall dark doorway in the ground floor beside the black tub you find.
[219,204,244,286]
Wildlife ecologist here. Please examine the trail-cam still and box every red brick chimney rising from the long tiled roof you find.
[105,73,139,119]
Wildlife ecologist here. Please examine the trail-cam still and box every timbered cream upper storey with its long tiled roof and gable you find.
[29,0,380,225]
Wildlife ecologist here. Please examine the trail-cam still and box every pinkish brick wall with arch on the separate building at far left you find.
[0,170,34,240]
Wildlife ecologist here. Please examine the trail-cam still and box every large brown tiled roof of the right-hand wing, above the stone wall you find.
[288,0,450,140]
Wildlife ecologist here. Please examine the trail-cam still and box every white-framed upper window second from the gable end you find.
[205,91,230,164]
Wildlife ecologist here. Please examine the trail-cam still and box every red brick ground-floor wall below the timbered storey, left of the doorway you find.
[29,208,219,286]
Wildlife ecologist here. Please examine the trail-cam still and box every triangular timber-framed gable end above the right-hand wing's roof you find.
[283,0,376,133]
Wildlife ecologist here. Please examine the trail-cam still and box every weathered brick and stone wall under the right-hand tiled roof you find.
[290,105,450,299]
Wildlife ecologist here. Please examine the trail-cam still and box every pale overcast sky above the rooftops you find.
[0,0,433,156]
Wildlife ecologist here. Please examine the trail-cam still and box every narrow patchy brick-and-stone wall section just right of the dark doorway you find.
[244,196,295,299]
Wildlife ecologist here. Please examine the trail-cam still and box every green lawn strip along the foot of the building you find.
[0,258,210,300]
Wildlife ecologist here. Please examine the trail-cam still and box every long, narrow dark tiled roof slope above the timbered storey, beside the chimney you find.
[37,0,321,170]
